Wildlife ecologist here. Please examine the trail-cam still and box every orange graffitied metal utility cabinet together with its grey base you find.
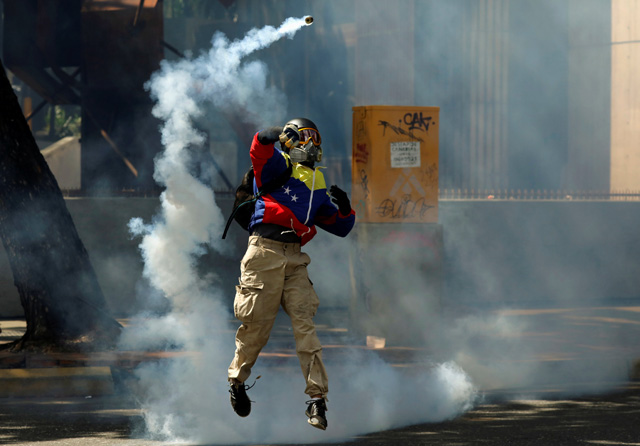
[350,106,442,344]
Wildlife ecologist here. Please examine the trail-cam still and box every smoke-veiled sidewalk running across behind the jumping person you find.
[0,302,640,396]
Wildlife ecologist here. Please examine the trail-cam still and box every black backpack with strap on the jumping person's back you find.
[222,163,293,239]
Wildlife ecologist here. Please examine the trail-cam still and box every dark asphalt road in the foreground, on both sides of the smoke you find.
[0,382,640,446]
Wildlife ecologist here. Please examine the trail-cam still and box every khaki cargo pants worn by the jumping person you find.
[228,236,329,397]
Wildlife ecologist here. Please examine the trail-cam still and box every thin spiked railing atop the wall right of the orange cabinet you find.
[439,189,640,201]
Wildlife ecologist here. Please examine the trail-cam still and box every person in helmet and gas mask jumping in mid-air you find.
[228,118,356,430]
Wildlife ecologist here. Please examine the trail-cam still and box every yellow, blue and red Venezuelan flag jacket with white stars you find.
[249,133,356,245]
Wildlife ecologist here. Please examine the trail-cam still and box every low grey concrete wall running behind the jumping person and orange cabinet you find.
[0,197,640,317]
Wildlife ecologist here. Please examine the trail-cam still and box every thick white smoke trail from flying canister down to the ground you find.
[121,18,475,443]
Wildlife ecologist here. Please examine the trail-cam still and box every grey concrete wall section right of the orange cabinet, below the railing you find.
[440,201,640,305]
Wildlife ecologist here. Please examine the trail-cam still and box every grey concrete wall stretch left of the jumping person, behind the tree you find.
[0,198,244,318]
